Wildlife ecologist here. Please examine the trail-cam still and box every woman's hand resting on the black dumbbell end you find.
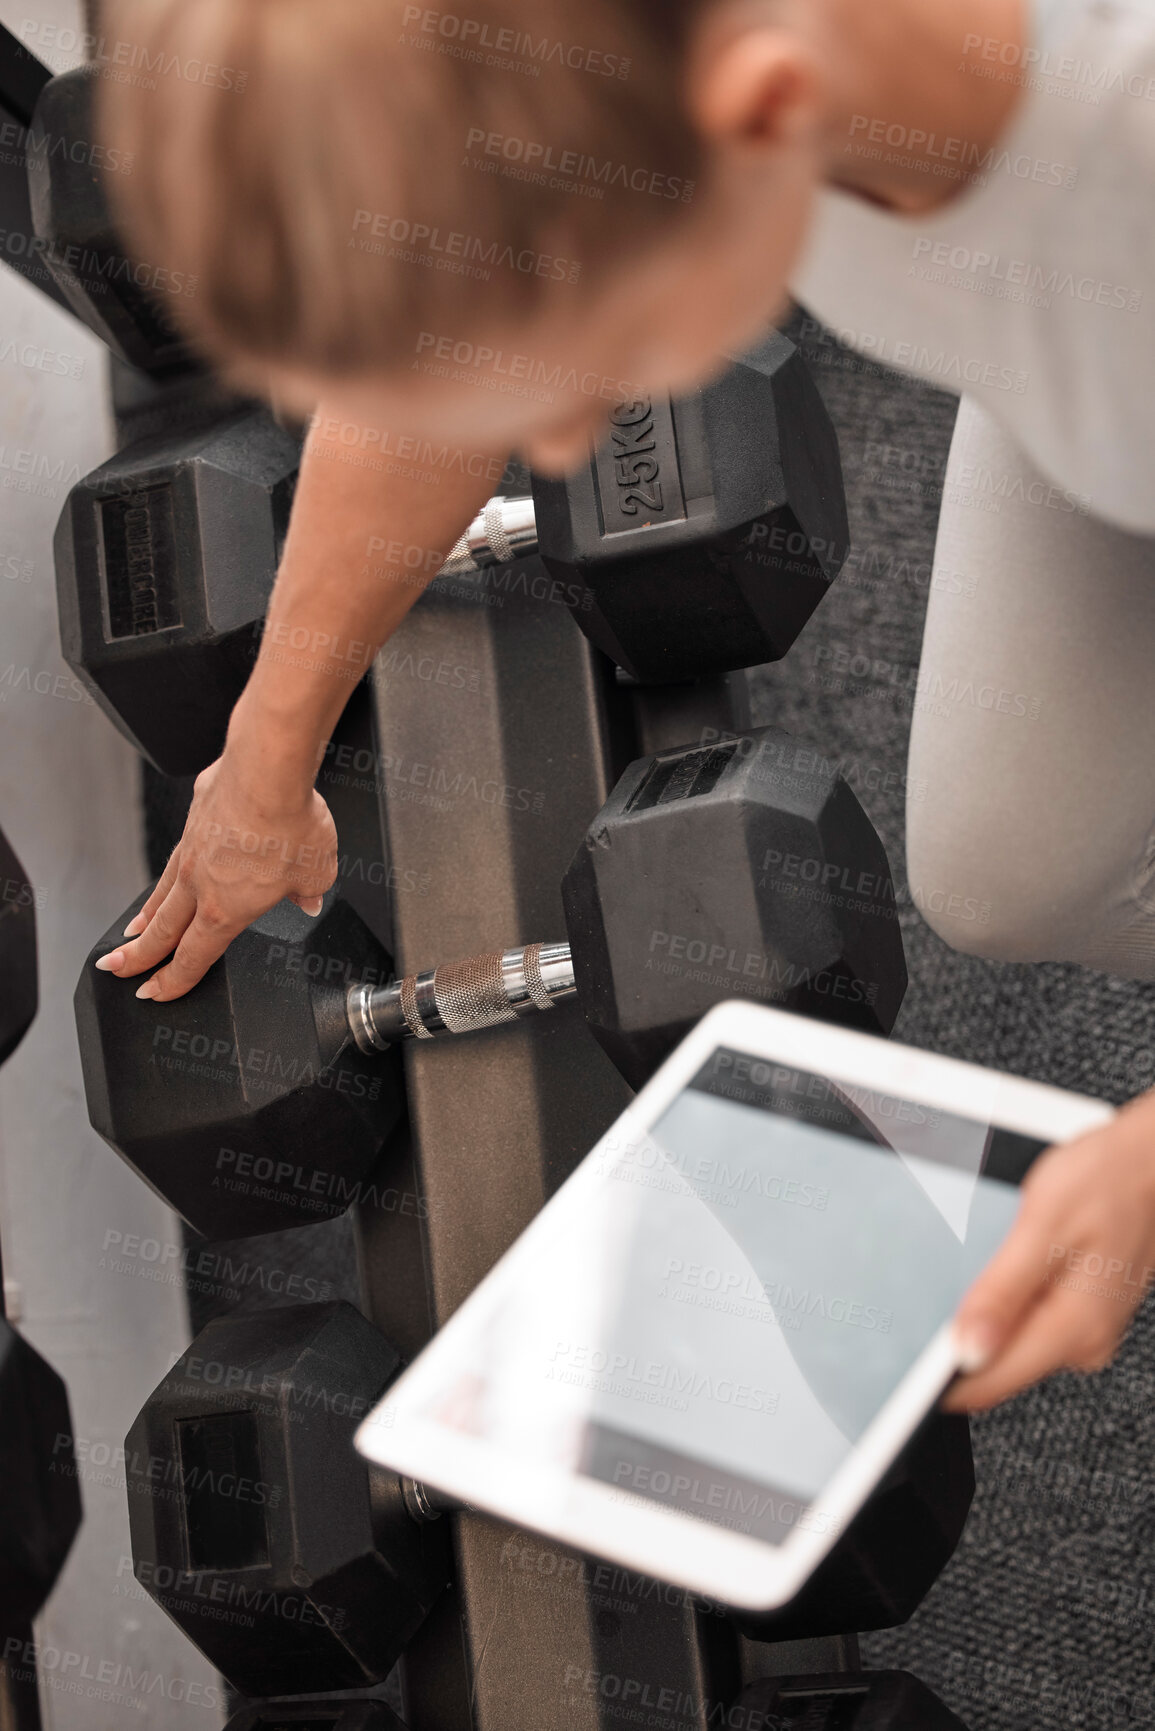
[97,748,338,1004]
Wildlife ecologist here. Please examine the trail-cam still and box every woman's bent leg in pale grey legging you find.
[907,400,1155,980]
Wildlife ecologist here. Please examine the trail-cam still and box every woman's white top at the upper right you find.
[793,0,1155,535]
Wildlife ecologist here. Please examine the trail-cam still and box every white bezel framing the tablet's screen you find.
[357,1002,1113,1612]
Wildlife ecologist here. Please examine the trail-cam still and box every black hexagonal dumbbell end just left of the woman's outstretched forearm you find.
[54,409,300,775]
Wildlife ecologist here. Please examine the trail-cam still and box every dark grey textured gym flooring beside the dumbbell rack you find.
[149,320,1155,1731]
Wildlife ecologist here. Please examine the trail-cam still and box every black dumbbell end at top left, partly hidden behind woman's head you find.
[28,66,196,376]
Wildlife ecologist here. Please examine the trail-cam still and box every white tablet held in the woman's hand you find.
[357,1004,1112,1610]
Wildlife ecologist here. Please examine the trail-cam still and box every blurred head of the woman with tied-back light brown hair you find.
[100,0,821,460]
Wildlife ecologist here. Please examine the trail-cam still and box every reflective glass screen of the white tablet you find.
[426,1049,1044,1544]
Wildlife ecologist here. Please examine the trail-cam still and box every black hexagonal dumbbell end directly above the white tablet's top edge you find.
[563,727,906,1087]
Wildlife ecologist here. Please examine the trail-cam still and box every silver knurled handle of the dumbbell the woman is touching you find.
[346,943,577,1052]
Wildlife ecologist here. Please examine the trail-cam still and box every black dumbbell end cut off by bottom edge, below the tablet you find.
[731,1670,966,1731]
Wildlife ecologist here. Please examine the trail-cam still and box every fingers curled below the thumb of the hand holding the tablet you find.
[944,1286,1131,1412]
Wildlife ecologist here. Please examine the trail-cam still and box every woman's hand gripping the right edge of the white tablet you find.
[944,1094,1155,1412]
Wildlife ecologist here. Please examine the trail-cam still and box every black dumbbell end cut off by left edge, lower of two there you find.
[0,1319,81,1634]
